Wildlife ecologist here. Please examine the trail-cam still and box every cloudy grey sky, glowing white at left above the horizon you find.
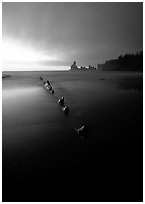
[2,2,143,71]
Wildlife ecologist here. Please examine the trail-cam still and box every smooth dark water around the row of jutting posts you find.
[2,72,143,202]
